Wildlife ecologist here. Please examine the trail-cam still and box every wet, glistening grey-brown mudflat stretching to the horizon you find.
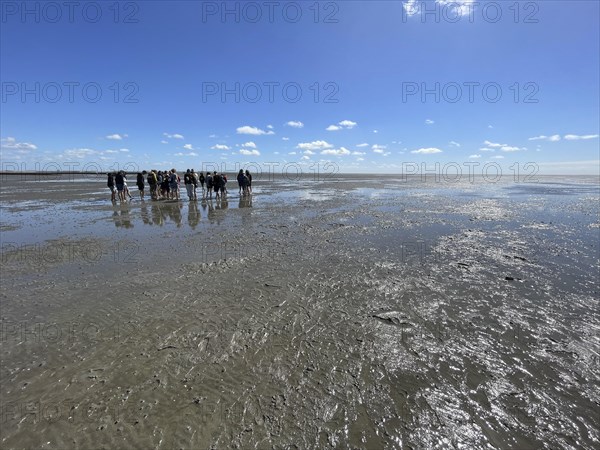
[0,176,600,449]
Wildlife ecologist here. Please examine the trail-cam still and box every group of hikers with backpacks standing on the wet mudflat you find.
[107,169,252,202]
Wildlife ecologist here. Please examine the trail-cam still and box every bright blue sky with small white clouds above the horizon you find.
[0,0,600,174]
